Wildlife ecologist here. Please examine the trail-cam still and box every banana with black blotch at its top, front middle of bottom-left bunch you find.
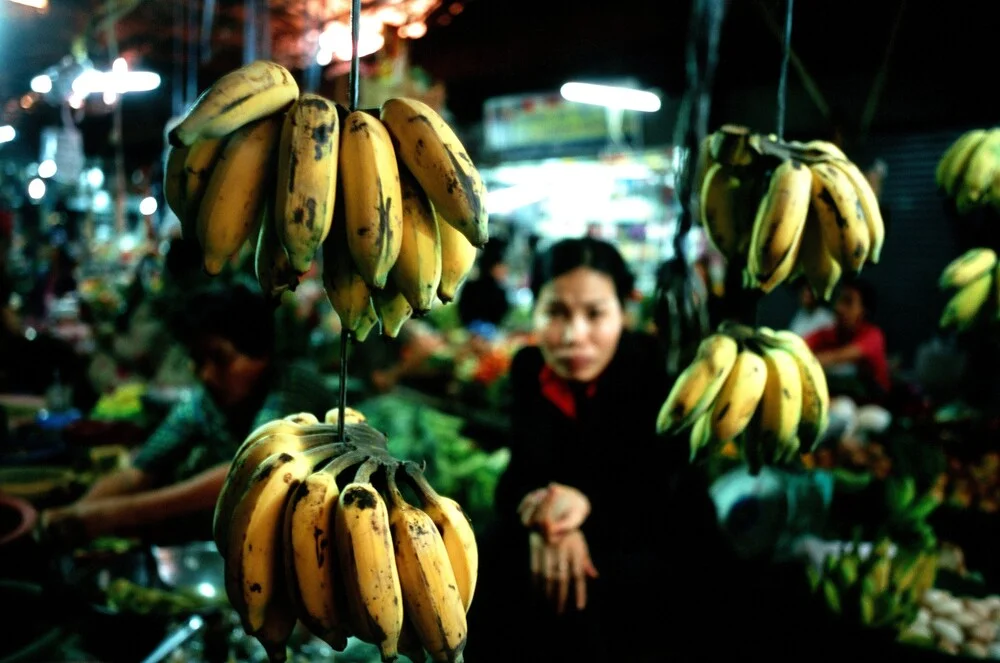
[333,460,403,661]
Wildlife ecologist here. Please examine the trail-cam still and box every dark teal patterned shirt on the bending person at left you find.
[132,364,335,485]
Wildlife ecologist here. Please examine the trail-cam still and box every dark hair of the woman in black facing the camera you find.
[531,237,635,303]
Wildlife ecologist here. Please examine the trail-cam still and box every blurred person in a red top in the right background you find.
[805,279,891,404]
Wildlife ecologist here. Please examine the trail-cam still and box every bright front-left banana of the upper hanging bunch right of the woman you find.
[747,159,812,292]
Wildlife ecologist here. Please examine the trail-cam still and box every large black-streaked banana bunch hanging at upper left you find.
[164,60,489,341]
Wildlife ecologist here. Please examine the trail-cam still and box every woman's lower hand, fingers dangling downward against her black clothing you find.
[529,530,597,614]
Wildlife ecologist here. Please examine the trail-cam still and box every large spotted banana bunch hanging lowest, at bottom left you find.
[213,408,479,663]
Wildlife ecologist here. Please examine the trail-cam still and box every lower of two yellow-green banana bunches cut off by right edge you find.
[939,248,1000,332]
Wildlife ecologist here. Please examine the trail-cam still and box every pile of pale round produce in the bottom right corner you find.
[901,589,1000,659]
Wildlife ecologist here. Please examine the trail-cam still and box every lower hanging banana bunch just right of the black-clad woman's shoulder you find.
[656,323,830,473]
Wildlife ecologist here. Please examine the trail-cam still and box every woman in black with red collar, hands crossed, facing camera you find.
[467,238,728,661]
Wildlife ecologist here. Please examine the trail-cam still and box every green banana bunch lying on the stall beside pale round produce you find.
[809,540,937,632]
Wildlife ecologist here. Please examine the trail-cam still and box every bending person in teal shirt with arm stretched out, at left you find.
[42,285,334,542]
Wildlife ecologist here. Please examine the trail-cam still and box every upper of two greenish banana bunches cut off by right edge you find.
[934,128,1000,214]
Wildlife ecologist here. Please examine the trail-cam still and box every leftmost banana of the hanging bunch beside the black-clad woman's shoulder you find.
[656,333,739,433]
